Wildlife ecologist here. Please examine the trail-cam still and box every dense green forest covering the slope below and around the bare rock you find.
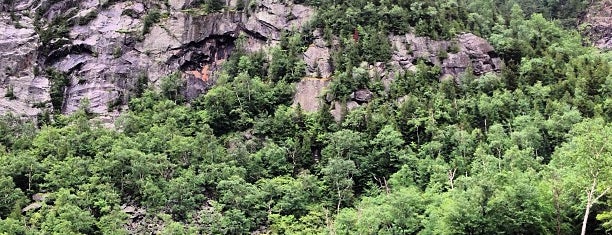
[0,0,612,235]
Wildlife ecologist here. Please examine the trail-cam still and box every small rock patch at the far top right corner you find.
[582,0,612,50]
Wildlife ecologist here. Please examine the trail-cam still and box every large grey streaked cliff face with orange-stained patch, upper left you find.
[0,0,313,122]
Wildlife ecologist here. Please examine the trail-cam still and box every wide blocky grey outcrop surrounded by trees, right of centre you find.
[390,33,501,77]
